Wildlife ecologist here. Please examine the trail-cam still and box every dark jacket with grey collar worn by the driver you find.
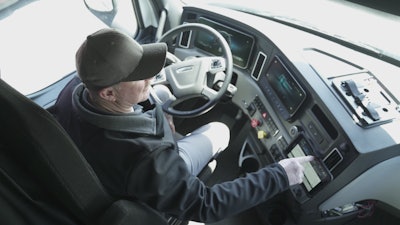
[54,76,289,222]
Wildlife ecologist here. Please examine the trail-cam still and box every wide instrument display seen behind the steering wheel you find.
[194,18,254,68]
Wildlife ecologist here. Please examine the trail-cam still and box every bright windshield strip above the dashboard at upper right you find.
[184,0,400,65]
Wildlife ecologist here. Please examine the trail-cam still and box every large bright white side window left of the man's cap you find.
[0,0,105,94]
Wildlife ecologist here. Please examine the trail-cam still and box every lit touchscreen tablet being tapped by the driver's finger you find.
[288,139,322,192]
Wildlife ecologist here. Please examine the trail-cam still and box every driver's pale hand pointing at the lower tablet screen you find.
[278,156,314,186]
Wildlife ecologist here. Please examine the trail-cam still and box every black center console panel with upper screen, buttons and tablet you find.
[239,56,356,203]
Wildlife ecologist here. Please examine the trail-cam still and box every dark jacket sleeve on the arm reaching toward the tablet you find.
[127,147,289,222]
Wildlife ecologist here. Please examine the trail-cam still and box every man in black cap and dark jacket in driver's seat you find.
[55,29,312,222]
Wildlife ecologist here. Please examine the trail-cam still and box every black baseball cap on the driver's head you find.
[76,28,167,89]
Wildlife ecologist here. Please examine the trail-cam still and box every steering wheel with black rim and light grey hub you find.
[158,23,233,117]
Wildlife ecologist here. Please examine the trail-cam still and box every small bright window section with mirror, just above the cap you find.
[84,0,139,37]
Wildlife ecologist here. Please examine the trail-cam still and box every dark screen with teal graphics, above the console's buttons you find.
[266,57,306,115]
